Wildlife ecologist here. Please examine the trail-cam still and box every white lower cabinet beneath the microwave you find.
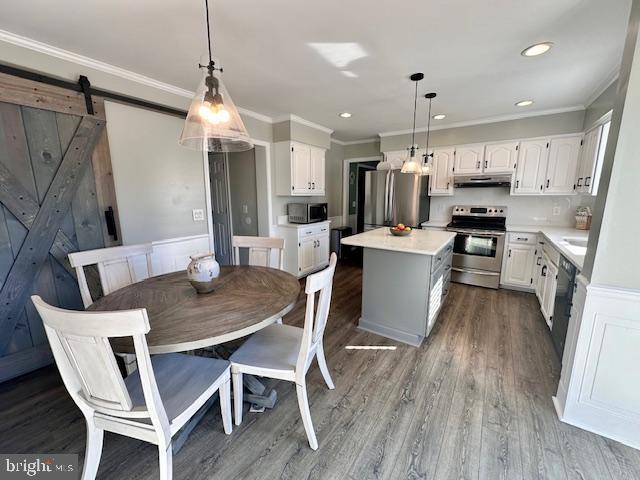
[277,222,329,277]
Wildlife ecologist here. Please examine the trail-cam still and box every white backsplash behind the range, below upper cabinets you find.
[429,187,595,227]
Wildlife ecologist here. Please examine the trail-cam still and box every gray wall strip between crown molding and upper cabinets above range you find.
[380,110,584,152]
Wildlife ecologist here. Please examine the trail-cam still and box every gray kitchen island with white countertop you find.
[342,227,455,347]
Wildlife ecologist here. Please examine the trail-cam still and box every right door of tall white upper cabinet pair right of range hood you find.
[544,135,582,195]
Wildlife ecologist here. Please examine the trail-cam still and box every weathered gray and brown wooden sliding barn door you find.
[0,85,119,381]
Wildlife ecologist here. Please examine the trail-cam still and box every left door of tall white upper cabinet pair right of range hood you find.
[511,139,549,195]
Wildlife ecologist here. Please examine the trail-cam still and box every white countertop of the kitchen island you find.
[342,227,456,255]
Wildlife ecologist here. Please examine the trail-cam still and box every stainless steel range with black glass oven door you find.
[447,205,507,288]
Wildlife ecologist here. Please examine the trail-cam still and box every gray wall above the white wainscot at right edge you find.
[584,2,640,290]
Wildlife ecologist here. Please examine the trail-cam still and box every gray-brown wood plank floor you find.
[0,266,640,480]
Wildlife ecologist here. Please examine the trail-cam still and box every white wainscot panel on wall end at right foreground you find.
[556,286,640,449]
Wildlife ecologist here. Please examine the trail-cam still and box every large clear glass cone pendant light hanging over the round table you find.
[180,0,253,152]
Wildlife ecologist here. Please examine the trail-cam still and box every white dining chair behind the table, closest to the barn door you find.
[69,243,153,374]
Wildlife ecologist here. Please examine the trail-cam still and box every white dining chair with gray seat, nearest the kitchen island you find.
[229,253,337,450]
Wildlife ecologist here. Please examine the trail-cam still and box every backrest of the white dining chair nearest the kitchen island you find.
[296,253,338,372]
